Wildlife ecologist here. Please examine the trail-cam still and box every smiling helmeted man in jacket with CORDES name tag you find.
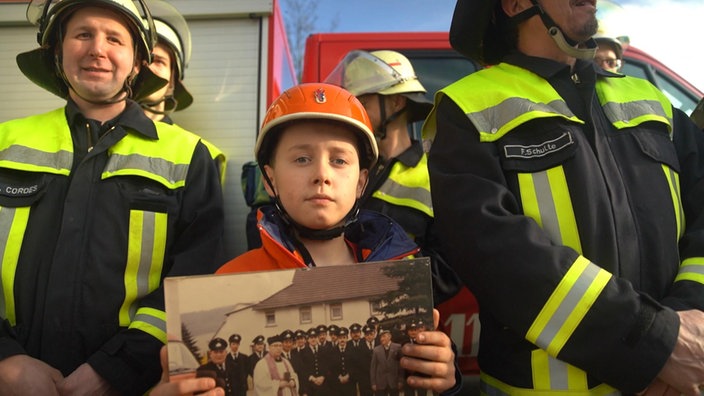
[0,0,223,395]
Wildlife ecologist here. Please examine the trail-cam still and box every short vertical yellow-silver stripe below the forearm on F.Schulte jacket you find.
[531,349,589,391]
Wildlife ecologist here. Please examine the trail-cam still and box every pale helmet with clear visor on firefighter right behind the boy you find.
[325,50,433,121]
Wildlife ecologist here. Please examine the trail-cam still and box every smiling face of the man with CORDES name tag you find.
[62,7,139,101]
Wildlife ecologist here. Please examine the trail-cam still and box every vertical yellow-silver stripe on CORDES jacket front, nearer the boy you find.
[119,210,168,326]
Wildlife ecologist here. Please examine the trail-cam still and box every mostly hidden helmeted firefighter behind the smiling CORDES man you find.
[135,0,227,185]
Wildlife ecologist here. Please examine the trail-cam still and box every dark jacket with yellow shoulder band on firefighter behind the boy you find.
[362,141,462,304]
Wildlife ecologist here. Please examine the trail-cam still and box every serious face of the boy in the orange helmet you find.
[264,121,367,230]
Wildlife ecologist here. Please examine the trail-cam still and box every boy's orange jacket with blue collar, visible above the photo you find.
[217,205,419,274]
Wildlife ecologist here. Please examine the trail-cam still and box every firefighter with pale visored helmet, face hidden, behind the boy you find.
[326,50,468,304]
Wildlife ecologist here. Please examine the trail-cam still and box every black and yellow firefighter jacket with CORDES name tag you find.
[0,101,223,395]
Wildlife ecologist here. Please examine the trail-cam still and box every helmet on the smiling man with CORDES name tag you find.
[17,0,167,98]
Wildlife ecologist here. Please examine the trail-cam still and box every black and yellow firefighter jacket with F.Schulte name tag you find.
[423,54,704,395]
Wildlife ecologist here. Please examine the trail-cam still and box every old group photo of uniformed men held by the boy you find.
[165,258,433,396]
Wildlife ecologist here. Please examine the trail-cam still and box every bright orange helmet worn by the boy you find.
[254,83,379,168]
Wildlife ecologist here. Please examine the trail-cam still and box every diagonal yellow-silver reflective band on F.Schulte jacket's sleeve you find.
[526,256,611,356]
